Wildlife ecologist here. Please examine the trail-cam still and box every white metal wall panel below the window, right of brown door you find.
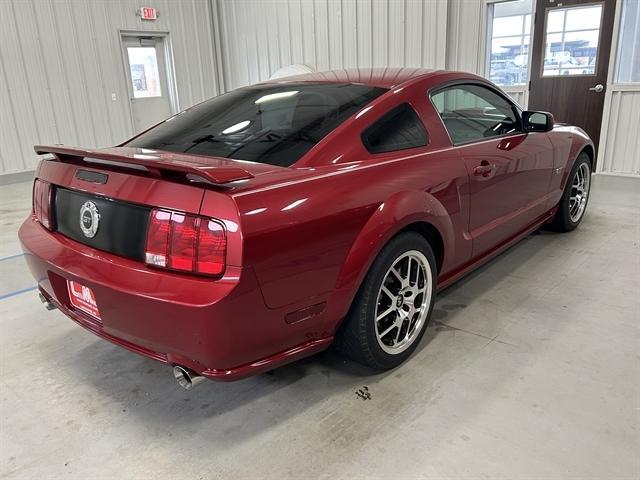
[598,86,640,175]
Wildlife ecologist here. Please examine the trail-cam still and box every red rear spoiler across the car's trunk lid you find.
[34,145,253,185]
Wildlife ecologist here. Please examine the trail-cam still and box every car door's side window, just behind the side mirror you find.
[431,85,521,145]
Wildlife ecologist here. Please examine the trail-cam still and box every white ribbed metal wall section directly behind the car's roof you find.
[218,0,447,89]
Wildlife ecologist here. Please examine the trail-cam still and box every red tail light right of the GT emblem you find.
[145,209,227,275]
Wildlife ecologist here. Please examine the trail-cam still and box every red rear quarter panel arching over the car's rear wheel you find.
[234,149,471,333]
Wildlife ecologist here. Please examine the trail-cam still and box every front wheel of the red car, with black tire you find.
[549,152,591,232]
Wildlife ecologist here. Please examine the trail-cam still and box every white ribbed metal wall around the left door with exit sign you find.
[0,0,221,173]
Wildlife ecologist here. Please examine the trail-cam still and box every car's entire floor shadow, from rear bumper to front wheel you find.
[52,227,576,442]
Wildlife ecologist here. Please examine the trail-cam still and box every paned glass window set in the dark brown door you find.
[542,4,602,77]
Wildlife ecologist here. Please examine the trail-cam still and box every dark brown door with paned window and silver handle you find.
[529,0,616,153]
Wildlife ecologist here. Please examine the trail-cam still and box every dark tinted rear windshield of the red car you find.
[127,83,386,167]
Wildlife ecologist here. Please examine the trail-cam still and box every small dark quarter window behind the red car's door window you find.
[362,103,429,153]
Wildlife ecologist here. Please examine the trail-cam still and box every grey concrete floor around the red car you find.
[0,176,640,480]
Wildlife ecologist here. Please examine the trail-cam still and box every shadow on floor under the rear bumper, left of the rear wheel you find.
[57,332,386,443]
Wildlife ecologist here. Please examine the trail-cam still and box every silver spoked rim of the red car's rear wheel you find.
[375,250,433,355]
